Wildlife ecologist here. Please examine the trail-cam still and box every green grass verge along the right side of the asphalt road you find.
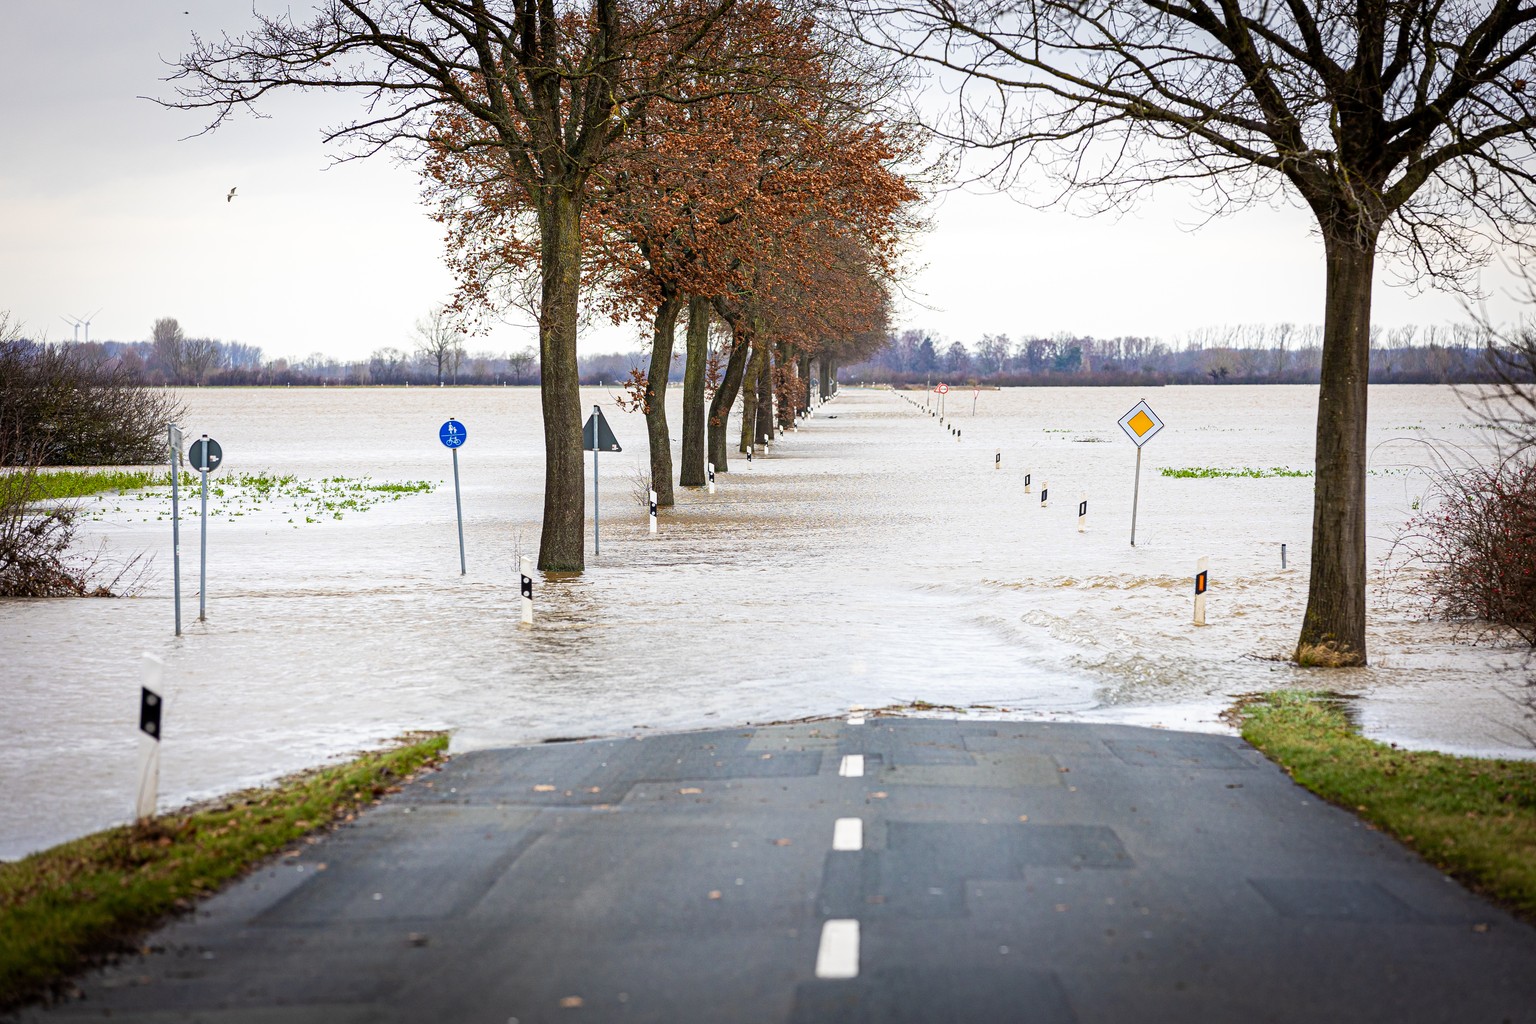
[1238,692,1536,921]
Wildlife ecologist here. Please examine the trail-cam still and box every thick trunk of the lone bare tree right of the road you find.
[1296,227,1376,666]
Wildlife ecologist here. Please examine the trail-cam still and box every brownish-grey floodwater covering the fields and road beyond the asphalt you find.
[0,387,1531,857]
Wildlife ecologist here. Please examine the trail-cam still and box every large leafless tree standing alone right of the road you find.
[846,0,1536,665]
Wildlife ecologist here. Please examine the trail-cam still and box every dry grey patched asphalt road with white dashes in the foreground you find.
[25,717,1536,1024]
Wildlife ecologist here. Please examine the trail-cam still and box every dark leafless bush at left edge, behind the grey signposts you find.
[0,312,181,465]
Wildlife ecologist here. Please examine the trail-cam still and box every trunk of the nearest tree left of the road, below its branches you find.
[539,187,587,573]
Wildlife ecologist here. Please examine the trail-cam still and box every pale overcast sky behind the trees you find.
[0,0,1516,359]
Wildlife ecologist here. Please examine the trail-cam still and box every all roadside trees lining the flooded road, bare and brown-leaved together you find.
[12,0,1536,665]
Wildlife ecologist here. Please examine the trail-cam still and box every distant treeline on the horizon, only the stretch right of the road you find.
[839,324,1496,387]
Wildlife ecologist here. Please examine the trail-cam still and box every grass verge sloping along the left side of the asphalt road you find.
[0,732,449,1012]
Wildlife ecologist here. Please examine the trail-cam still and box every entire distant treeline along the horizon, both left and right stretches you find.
[14,321,1496,387]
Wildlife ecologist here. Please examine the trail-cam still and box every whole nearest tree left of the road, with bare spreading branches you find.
[169,0,753,570]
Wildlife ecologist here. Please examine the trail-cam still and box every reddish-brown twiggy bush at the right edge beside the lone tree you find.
[1398,450,1536,648]
